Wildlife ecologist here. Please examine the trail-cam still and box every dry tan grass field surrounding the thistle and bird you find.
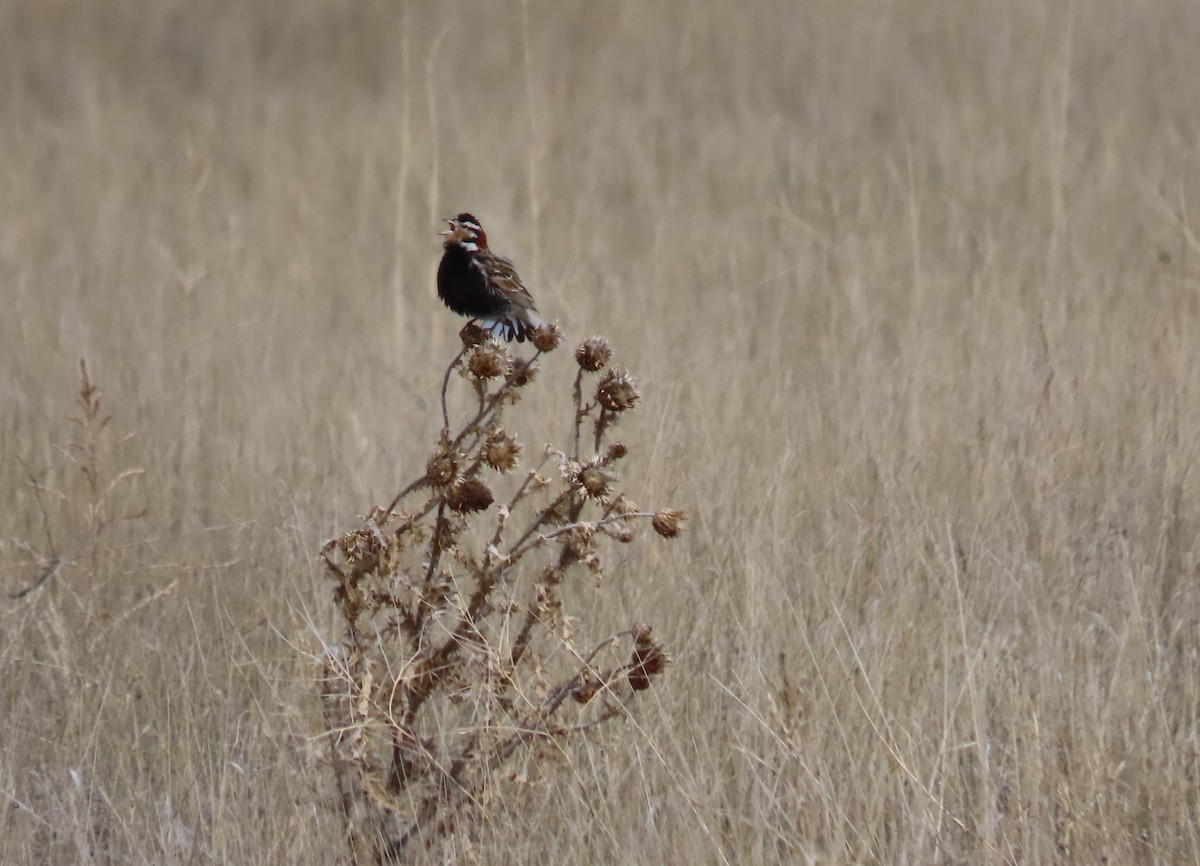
[0,0,1200,866]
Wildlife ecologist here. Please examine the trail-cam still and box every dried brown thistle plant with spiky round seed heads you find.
[322,324,683,862]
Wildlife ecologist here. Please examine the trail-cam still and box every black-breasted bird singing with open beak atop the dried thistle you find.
[438,214,545,343]
